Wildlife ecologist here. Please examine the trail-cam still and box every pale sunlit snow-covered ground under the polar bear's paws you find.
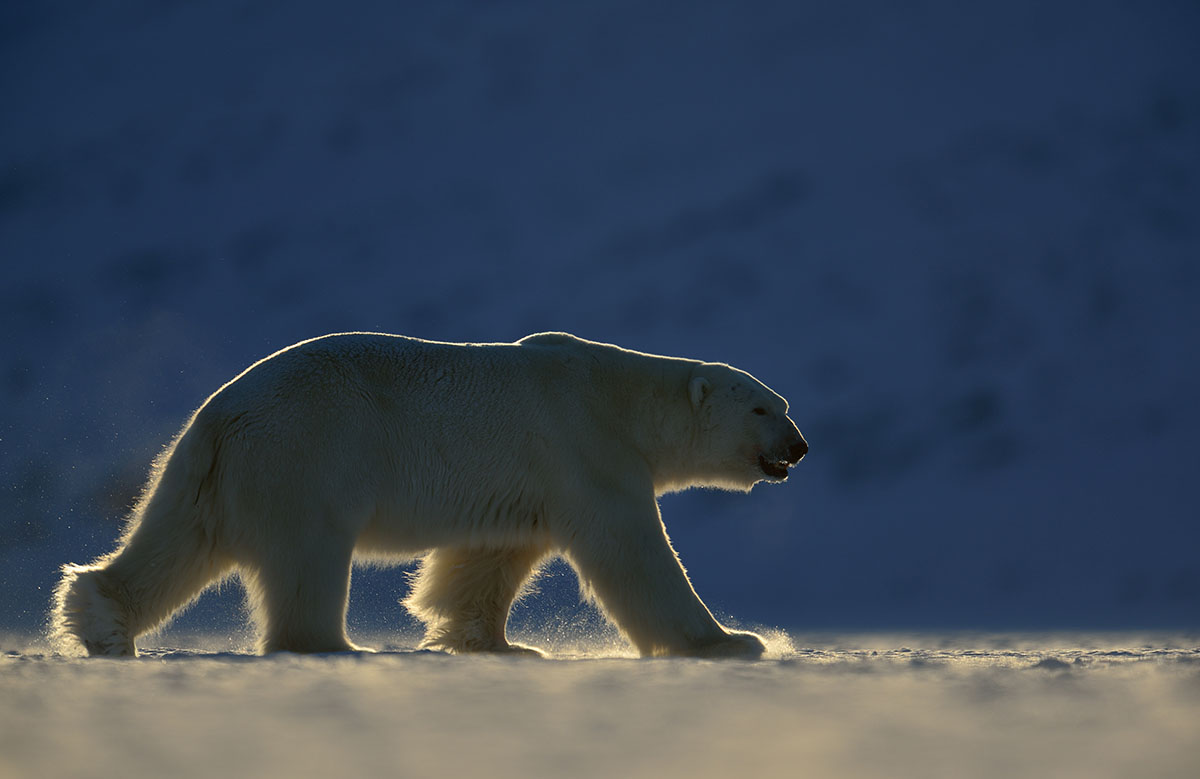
[0,634,1200,779]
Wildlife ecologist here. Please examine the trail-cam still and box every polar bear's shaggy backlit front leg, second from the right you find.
[404,546,547,655]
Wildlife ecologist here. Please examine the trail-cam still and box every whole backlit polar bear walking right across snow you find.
[50,332,808,658]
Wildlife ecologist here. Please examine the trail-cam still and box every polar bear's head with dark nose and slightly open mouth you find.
[688,362,809,491]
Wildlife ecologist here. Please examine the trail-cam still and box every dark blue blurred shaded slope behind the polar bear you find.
[0,0,1200,628]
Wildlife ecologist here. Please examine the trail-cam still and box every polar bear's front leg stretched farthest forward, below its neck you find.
[566,496,766,658]
